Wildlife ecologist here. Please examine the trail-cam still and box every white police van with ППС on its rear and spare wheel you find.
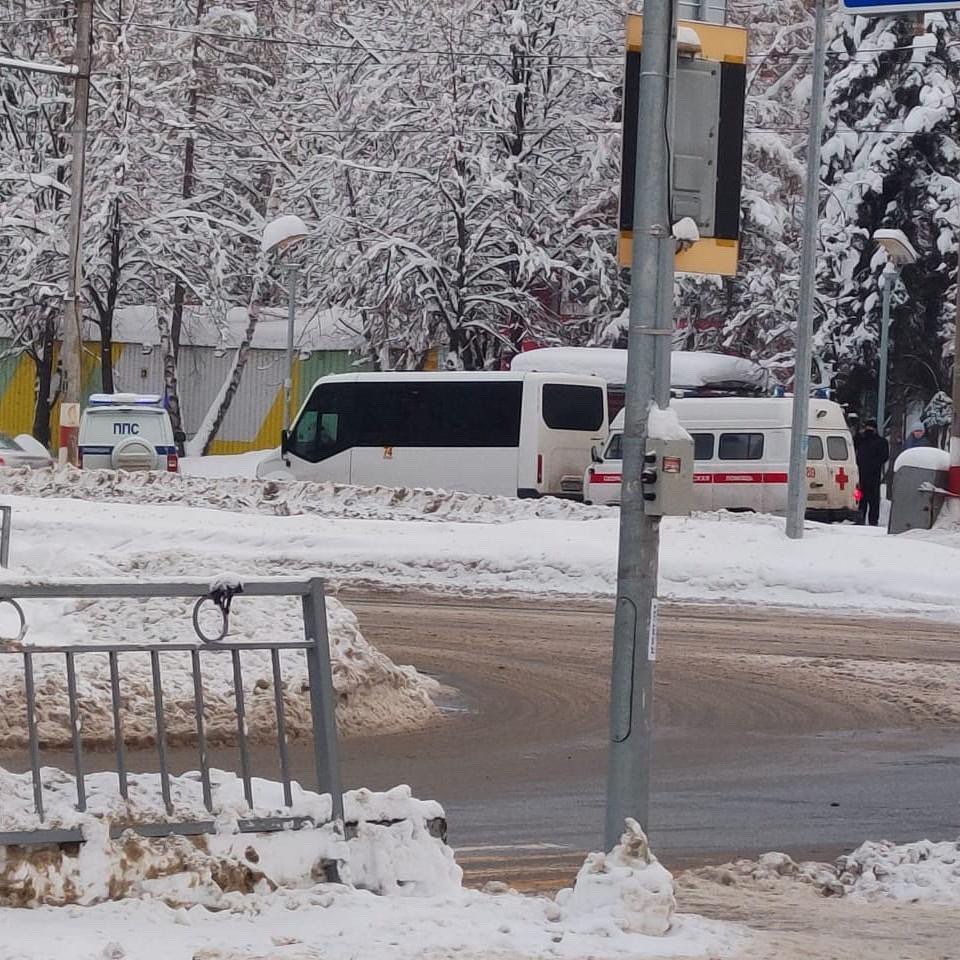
[79,393,180,473]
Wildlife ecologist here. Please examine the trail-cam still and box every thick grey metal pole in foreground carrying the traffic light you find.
[605,0,675,849]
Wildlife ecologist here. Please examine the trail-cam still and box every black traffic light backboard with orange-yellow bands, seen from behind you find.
[618,14,747,276]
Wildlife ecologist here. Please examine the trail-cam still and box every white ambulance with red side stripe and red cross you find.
[584,397,859,520]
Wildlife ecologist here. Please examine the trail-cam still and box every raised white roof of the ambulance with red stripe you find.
[610,397,848,430]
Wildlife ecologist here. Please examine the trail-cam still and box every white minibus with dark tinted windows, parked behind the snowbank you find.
[257,372,607,499]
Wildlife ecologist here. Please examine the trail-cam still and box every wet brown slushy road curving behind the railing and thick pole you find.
[11,593,960,886]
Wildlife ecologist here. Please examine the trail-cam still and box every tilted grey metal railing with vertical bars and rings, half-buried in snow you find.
[0,579,343,845]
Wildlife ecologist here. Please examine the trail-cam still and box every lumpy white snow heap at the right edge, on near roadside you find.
[837,840,960,905]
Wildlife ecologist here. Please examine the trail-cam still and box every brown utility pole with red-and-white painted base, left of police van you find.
[59,0,93,465]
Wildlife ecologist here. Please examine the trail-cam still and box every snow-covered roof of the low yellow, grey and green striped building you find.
[84,306,363,351]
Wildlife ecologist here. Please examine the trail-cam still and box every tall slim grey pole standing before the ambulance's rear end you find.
[787,0,826,540]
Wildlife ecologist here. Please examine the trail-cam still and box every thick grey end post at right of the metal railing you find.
[303,579,343,830]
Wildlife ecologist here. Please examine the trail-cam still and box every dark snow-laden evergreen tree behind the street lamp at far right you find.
[818,14,960,431]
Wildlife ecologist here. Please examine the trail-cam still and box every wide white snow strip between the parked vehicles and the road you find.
[0,471,960,620]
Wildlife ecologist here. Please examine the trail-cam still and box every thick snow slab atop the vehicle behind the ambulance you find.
[510,347,766,388]
